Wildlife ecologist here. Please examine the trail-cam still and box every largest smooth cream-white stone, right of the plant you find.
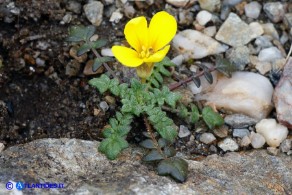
[195,72,274,120]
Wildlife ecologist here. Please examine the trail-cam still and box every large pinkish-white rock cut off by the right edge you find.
[273,58,292,129]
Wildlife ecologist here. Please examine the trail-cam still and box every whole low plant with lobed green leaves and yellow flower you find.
[67,12,233,182]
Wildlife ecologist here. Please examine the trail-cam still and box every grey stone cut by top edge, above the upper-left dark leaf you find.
[83,1,103,26]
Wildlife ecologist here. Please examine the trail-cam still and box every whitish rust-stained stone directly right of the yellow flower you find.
[172,30,228,60]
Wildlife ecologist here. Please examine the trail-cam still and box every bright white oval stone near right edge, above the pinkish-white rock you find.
[258,47,283,62]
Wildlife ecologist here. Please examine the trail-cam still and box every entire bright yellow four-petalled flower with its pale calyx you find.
[112,11,177,80]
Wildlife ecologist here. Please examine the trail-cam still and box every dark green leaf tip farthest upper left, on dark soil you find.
[66,25,95,42]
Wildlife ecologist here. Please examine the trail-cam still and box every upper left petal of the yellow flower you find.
[124,16,148,53]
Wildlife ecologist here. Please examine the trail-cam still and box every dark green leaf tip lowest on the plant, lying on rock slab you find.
[157,157,188,182]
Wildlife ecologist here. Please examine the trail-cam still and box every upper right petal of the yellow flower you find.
[149,11,177,51]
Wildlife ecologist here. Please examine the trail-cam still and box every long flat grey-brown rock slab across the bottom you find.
[0,139,292,195]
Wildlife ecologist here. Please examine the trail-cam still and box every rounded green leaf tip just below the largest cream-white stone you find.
[202,106,224,129]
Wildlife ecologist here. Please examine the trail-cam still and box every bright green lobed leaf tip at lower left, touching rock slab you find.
[98,136,128,160]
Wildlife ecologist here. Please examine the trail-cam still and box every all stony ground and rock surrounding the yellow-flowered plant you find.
[0,0,292,194]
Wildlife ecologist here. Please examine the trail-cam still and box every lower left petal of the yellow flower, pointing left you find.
[112,46,143,67]
